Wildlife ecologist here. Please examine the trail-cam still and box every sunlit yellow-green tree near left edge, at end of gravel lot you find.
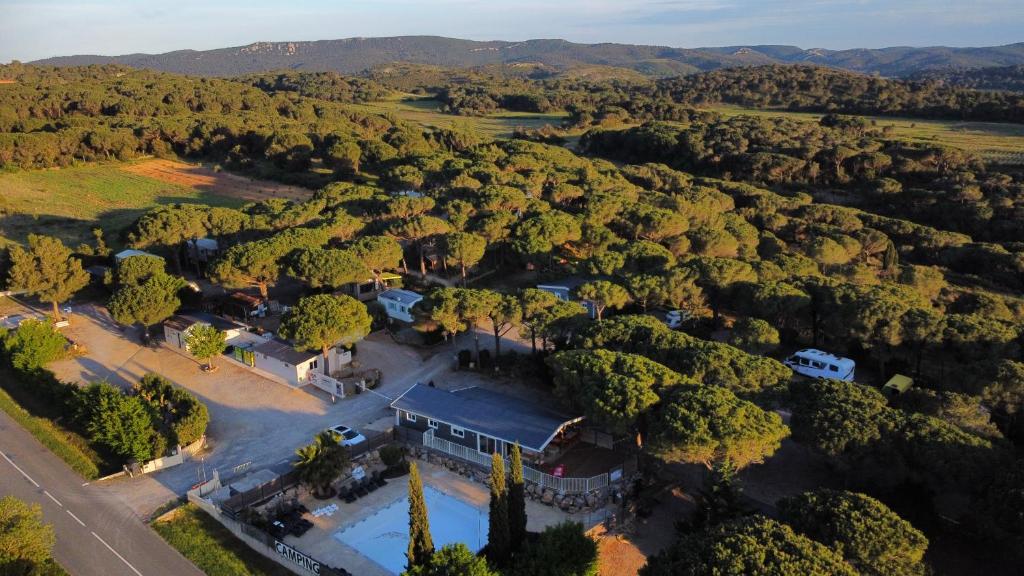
[7,234,89,322]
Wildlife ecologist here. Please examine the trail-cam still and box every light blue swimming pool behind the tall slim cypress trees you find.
[334,486,487,574]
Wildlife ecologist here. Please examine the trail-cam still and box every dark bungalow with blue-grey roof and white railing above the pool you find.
[391,384,583,461]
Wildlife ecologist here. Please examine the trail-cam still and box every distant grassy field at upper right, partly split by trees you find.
[711,106,1024,164]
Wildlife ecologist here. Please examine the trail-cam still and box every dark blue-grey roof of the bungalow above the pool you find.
[391,384,582,452]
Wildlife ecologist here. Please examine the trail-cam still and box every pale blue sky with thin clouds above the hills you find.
[0,0,1024,63]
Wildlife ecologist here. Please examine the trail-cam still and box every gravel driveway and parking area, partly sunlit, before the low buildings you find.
[49,306,453,517]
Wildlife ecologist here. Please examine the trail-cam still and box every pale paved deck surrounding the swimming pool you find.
[285,460,592,576]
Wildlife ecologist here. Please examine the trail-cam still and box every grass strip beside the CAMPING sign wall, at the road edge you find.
[153,504,292,576]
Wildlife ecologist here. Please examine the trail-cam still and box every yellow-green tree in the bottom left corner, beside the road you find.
[0,496,62,576]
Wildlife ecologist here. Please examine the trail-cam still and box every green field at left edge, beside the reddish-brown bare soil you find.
[0,164,243,246]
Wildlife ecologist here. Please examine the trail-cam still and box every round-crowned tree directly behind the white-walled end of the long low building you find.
[278,294,372,374]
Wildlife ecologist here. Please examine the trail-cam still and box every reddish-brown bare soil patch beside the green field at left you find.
[121,159,312,202]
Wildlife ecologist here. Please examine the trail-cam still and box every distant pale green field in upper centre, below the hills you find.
[349,94,566,138]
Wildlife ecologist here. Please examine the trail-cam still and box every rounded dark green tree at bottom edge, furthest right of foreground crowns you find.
[778,490,928,576]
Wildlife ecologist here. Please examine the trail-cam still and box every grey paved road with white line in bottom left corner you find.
[0,412,203,576]
